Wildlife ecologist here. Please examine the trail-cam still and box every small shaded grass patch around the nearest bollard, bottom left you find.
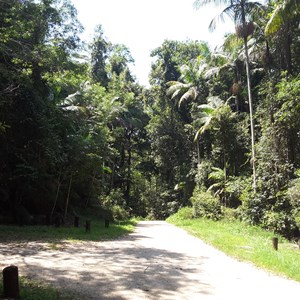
[0,275,81,300]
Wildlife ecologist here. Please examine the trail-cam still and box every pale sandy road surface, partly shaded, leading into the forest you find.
[0,221,300,300]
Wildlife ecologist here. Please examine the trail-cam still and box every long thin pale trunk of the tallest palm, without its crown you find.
[244,37,256,191]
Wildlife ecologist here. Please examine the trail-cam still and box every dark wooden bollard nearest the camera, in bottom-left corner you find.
[2,266,20,299]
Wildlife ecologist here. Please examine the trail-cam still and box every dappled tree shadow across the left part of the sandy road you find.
[0,224,212,300]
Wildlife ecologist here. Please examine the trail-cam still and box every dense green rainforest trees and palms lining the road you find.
[0,0,300,238]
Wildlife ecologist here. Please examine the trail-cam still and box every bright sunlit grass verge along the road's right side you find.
[167,215,300,281]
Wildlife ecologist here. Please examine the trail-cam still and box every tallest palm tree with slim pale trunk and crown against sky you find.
[194,0,261,190]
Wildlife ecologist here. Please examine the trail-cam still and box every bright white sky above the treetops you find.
[71,0,233,86]
